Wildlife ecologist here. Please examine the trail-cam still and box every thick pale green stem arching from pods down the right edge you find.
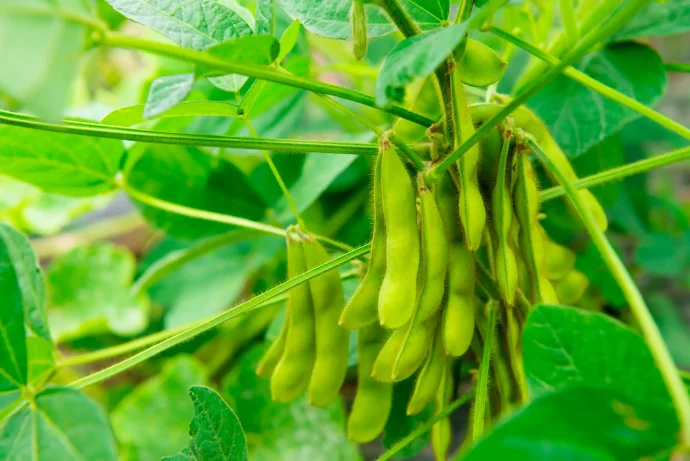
[527,139,690,447]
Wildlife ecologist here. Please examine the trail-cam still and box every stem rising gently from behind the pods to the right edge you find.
[539,147,690,202]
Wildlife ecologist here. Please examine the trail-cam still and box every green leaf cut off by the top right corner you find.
[614,0,690,40]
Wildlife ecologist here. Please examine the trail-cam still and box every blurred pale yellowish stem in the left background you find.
[31,211,146,259]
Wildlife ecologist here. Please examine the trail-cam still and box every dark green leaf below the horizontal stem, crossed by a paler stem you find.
[127,146,266,239]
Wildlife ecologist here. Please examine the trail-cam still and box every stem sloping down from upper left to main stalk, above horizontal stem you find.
[102,32,434,127]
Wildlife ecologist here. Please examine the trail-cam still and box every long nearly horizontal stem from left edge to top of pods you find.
[0,110,378,155]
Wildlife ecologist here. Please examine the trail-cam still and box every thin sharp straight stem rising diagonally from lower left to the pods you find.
[70,244,371,389]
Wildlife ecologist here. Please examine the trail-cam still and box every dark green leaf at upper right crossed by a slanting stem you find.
[528,42,666,156]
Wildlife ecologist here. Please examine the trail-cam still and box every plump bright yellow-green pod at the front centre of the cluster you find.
[379,146,419,329]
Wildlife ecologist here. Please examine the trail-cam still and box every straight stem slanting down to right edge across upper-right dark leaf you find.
[488,26,690,139]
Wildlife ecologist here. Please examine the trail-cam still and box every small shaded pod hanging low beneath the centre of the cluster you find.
[407,328,447,415]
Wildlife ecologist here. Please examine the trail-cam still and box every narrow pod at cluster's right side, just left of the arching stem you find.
[513,152,558,304]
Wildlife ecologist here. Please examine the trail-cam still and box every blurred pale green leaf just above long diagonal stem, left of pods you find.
[145,238,285,328]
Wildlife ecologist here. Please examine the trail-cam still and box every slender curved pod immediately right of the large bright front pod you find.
[415,175,448,322]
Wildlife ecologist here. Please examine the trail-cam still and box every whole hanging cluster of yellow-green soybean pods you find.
[257,97,606,453]
